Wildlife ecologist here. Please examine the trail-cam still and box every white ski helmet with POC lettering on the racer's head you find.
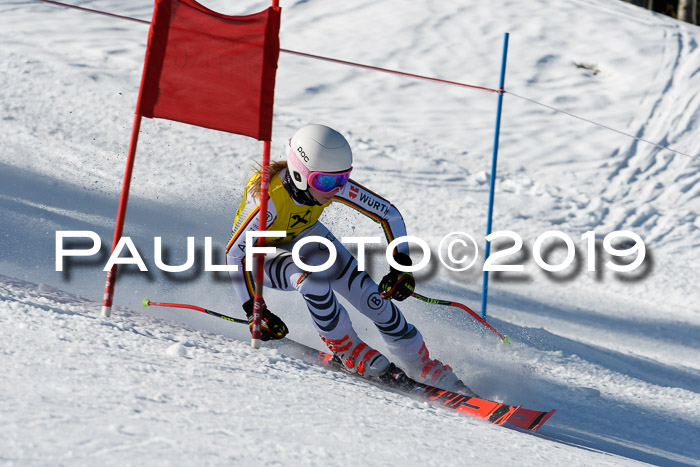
[287,124,352,190]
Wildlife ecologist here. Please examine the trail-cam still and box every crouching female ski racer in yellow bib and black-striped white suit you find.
[226,124,471,394]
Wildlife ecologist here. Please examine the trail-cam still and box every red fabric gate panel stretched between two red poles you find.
[137,0,280,141]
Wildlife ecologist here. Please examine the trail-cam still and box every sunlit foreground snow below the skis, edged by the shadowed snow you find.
[0,276,634,466]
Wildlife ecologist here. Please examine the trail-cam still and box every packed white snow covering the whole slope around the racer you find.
[0,0,700,465]
